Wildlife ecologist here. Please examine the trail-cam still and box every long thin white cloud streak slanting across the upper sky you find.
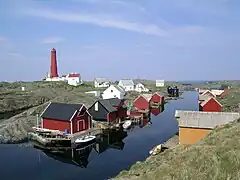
[23,9,168,36]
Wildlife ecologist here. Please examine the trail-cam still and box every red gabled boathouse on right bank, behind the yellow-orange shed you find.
[199,97,222,112]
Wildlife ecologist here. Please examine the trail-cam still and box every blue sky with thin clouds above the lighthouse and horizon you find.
[0,0,240,81]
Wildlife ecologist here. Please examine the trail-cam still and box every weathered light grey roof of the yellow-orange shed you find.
[175,110,240,129]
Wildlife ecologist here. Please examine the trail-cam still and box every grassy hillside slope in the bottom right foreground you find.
[114,119,240,180]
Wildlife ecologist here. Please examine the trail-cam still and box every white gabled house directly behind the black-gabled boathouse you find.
[102,85,126,99]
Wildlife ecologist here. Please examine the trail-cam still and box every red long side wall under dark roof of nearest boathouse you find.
[42,118,71,133]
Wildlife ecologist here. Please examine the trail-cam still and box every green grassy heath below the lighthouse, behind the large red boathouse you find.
[0,81,96,113]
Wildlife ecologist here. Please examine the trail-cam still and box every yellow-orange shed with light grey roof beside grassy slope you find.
[175,110,240,144]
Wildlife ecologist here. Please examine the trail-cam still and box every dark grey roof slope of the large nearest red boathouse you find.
[41,103,83,121]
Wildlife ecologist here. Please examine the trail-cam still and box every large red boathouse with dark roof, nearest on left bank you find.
[40,103,92,134]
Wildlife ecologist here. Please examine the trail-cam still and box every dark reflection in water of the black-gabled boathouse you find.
[94,129,127,154]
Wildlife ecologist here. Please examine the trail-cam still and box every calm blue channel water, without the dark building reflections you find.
[0,92,198,180]
